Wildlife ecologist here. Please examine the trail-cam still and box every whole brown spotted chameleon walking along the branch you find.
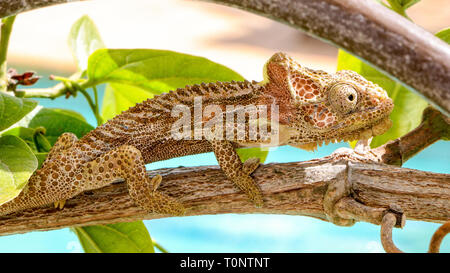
[0,52,393,216]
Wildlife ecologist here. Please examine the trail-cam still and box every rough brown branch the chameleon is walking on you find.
[0,155,450,235]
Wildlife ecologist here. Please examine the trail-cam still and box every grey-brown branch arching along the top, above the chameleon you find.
[0,0,450,116]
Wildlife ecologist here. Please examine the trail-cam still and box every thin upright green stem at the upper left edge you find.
[0,15,16,91]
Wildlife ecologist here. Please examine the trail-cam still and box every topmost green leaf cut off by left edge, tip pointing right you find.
[0,92,38,131]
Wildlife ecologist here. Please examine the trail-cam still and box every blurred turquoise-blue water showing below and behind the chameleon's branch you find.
[0,73,450,252]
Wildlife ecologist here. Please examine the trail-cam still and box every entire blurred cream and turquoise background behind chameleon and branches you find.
[0,0,450,252]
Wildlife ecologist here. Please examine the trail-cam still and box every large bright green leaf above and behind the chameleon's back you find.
[87,49,243,120]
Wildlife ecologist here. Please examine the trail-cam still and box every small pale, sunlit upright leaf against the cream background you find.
[68,15,105,71]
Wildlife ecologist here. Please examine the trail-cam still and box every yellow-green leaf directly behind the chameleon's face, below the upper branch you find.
[337,50,428,148]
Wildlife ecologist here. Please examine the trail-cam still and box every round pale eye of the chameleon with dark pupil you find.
[328,83,358,114]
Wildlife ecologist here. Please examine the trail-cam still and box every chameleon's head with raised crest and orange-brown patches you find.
[264,53,394,149]
